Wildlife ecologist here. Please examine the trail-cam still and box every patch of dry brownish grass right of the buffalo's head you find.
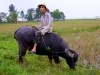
[63,30,100,65]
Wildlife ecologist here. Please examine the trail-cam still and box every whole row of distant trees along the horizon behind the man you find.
[0,4,65,23]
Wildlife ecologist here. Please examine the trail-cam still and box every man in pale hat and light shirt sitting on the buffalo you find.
[29,4,53,54]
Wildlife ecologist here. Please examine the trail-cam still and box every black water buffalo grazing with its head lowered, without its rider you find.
[14,26,80,69]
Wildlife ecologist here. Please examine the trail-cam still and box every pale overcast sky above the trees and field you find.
[0,0,100,19]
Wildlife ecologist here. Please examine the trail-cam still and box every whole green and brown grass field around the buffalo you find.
[0,20,100,75]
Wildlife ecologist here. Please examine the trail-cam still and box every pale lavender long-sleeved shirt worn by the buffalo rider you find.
[37,12,53,35]
